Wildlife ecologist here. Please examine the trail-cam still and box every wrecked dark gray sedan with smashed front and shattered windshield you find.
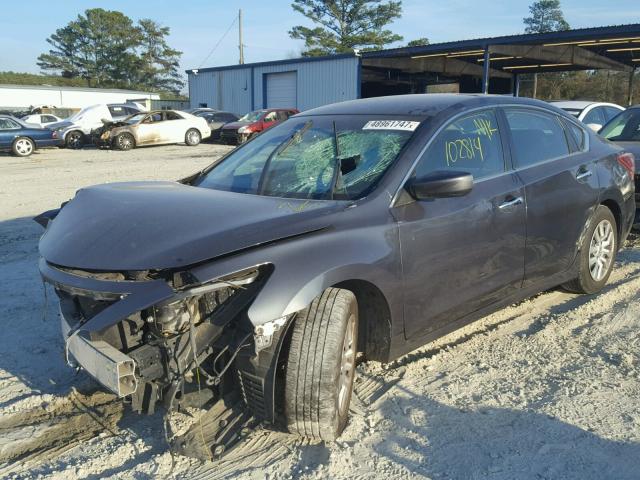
[37,95,634,455]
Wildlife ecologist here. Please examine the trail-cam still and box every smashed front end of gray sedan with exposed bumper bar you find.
[40,259,296,458]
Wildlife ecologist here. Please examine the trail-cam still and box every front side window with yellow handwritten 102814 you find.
[416,110,504,179]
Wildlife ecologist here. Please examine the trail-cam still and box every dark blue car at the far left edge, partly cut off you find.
[0,115,61,157]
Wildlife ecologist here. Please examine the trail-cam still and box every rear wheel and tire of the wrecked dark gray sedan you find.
[563,205,618,294]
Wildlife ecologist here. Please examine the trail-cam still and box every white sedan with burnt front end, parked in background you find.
[95,110,211,150]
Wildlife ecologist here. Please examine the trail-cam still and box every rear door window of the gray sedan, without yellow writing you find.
[505,109,569,168]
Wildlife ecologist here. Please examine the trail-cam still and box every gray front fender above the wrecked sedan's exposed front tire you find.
[191,222,402,325]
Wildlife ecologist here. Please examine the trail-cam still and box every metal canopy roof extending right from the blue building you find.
[362,24,640,77]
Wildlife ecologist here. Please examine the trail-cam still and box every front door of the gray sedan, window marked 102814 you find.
[392,110,526,340]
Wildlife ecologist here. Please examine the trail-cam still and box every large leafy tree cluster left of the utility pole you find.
[37,8,182,91]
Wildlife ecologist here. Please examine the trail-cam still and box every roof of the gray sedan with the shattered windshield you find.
[297,93,553,117]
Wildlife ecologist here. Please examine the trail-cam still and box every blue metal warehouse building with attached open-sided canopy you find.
[187,24,640,114]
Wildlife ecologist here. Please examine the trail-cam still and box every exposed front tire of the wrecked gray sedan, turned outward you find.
[285,288,358,441]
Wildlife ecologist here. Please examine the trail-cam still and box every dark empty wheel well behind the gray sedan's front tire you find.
[334,280,391,362]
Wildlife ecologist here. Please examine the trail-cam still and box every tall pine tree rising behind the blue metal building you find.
[289,0,402,56]
